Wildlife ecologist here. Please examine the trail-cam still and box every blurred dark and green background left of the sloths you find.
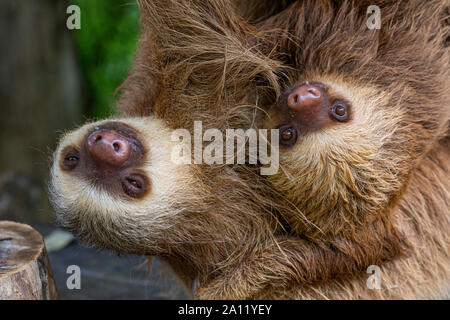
[0,0,186,299]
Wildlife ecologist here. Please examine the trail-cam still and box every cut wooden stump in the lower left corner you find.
[0,221,58,300]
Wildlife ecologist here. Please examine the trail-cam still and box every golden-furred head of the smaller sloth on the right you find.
[267,79,411,234]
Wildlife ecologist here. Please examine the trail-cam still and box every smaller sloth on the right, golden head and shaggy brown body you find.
[257,1,450,234]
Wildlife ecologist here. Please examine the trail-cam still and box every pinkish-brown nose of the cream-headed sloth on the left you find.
[87,129,130,167]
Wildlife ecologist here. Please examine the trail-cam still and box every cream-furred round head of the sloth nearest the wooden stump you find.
[50,117,197,254]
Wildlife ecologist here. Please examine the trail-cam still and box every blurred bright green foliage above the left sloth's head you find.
[69,0,139,118]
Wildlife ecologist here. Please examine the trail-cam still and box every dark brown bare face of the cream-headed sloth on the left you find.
[59,121,151,199]
